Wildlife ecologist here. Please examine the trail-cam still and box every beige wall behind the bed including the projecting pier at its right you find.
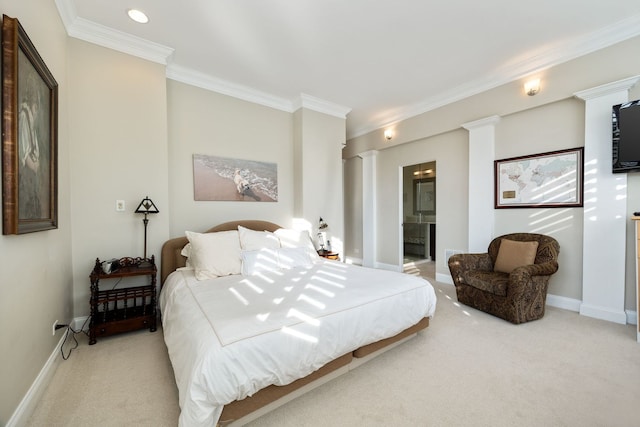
[167,80,345,249]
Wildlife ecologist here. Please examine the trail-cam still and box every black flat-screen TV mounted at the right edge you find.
[611,99,640,173]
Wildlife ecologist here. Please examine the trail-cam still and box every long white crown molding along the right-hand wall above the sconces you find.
[347,15,640,139]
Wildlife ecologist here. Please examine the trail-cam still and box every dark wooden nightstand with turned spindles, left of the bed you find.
[89,255,157,345]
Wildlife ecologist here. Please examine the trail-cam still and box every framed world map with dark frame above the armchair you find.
[494,147,584,209]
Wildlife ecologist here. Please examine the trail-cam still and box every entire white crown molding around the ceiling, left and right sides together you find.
[55,0,640,139]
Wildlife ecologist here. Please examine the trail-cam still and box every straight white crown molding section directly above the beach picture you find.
[167,64,294,113]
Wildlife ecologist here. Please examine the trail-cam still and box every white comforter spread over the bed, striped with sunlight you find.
[160,260,436,427]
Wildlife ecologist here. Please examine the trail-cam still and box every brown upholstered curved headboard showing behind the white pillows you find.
[160,220,282,284]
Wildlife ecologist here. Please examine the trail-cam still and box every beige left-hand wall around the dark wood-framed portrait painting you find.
[0,0,73,425]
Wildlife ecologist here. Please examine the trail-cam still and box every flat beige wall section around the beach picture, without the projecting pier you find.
[166,80,294,237]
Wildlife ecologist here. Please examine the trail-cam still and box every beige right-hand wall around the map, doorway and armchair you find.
[343,37,640,311]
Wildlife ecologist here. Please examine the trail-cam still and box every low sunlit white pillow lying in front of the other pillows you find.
[242,248,313,276]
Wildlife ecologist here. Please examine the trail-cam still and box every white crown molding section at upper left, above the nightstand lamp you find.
[55,0,174,65]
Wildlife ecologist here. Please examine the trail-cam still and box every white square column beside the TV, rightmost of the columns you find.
[574,76,640,324]
